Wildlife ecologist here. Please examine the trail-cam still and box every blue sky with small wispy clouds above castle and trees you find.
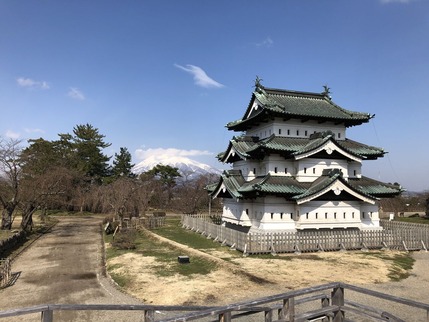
[0,0,429,191]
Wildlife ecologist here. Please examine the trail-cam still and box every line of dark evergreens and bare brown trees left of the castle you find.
[0,124,216,230]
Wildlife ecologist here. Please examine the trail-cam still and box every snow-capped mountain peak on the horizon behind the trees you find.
[132,157,222,179]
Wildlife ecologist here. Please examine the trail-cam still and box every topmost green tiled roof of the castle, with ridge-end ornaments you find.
[226,85,372,131]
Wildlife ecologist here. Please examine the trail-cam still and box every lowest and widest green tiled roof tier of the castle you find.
[210,169,403,200]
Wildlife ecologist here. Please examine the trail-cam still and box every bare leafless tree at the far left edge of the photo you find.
[0,139,22,230]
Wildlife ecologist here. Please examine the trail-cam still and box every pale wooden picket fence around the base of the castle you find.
[182,215,429,255]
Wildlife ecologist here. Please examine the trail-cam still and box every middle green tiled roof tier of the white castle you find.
[218,135,385,162]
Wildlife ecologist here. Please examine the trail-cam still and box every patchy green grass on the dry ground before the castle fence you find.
[105,217,414,285]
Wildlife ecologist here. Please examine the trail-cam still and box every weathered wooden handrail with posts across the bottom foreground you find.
[0,282,429,322]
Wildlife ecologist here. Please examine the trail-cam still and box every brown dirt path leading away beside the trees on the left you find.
[0,217,141,321]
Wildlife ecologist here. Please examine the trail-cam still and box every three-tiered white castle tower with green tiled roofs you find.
[208,78,402,232]
